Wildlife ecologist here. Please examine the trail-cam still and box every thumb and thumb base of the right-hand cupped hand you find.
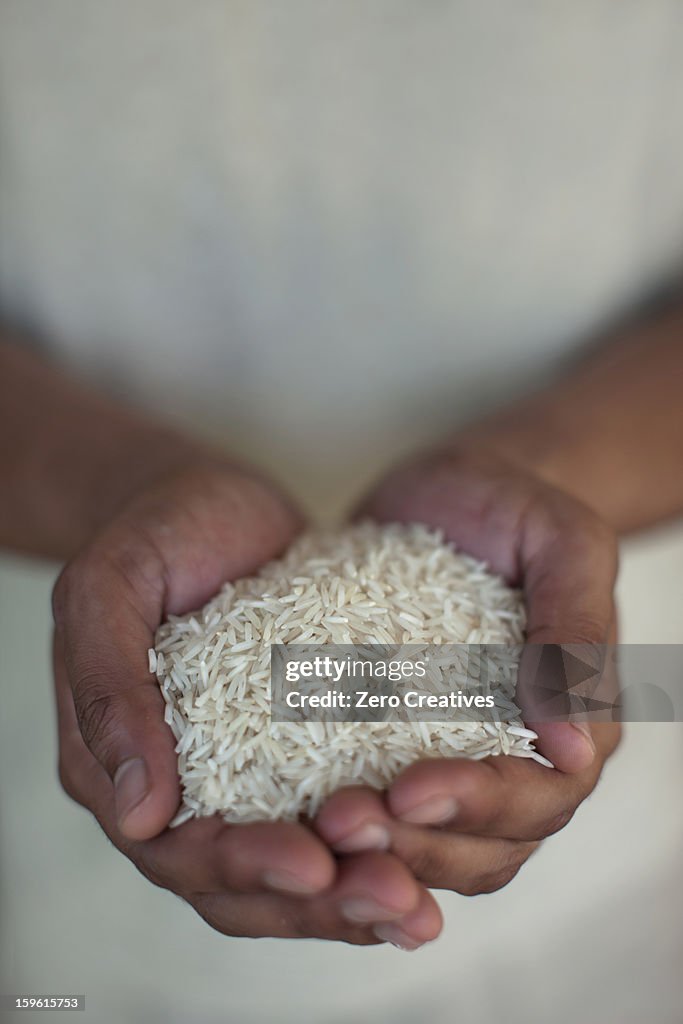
[359,451,617,772]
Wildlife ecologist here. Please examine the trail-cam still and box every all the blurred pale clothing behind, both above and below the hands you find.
[0,0,683,1024]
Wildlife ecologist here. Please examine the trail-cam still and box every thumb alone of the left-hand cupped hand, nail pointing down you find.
[55,546,180,839]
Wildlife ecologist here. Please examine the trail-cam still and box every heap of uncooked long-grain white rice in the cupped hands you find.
[150,522,547,825]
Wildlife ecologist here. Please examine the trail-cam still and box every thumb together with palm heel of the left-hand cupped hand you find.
[53,469,299,839]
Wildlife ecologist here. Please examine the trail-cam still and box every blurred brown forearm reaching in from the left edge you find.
[0,337,229,559]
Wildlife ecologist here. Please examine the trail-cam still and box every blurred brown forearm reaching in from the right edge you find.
[456,307,683,532]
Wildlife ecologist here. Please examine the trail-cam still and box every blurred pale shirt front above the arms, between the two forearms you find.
[0,0,683,507]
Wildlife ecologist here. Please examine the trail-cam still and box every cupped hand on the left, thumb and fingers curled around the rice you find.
[53,466,441,948]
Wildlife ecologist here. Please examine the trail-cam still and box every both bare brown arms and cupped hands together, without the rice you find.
[5,311,683,948]
